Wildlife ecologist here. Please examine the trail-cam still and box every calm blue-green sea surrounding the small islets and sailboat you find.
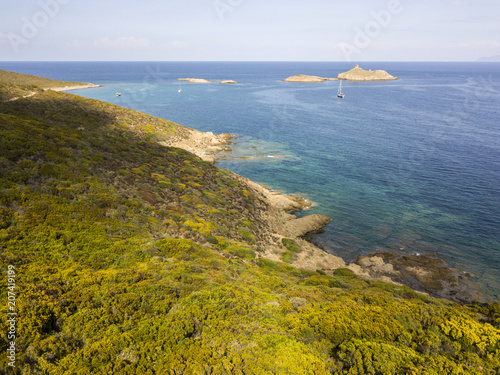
[0,62,500,302]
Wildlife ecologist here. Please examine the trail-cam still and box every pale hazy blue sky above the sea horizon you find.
[0,0,500,61]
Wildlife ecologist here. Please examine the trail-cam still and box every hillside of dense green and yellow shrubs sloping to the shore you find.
[0,81,500,374]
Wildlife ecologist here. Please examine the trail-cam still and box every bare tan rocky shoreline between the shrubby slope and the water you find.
[30,74,483,303]
